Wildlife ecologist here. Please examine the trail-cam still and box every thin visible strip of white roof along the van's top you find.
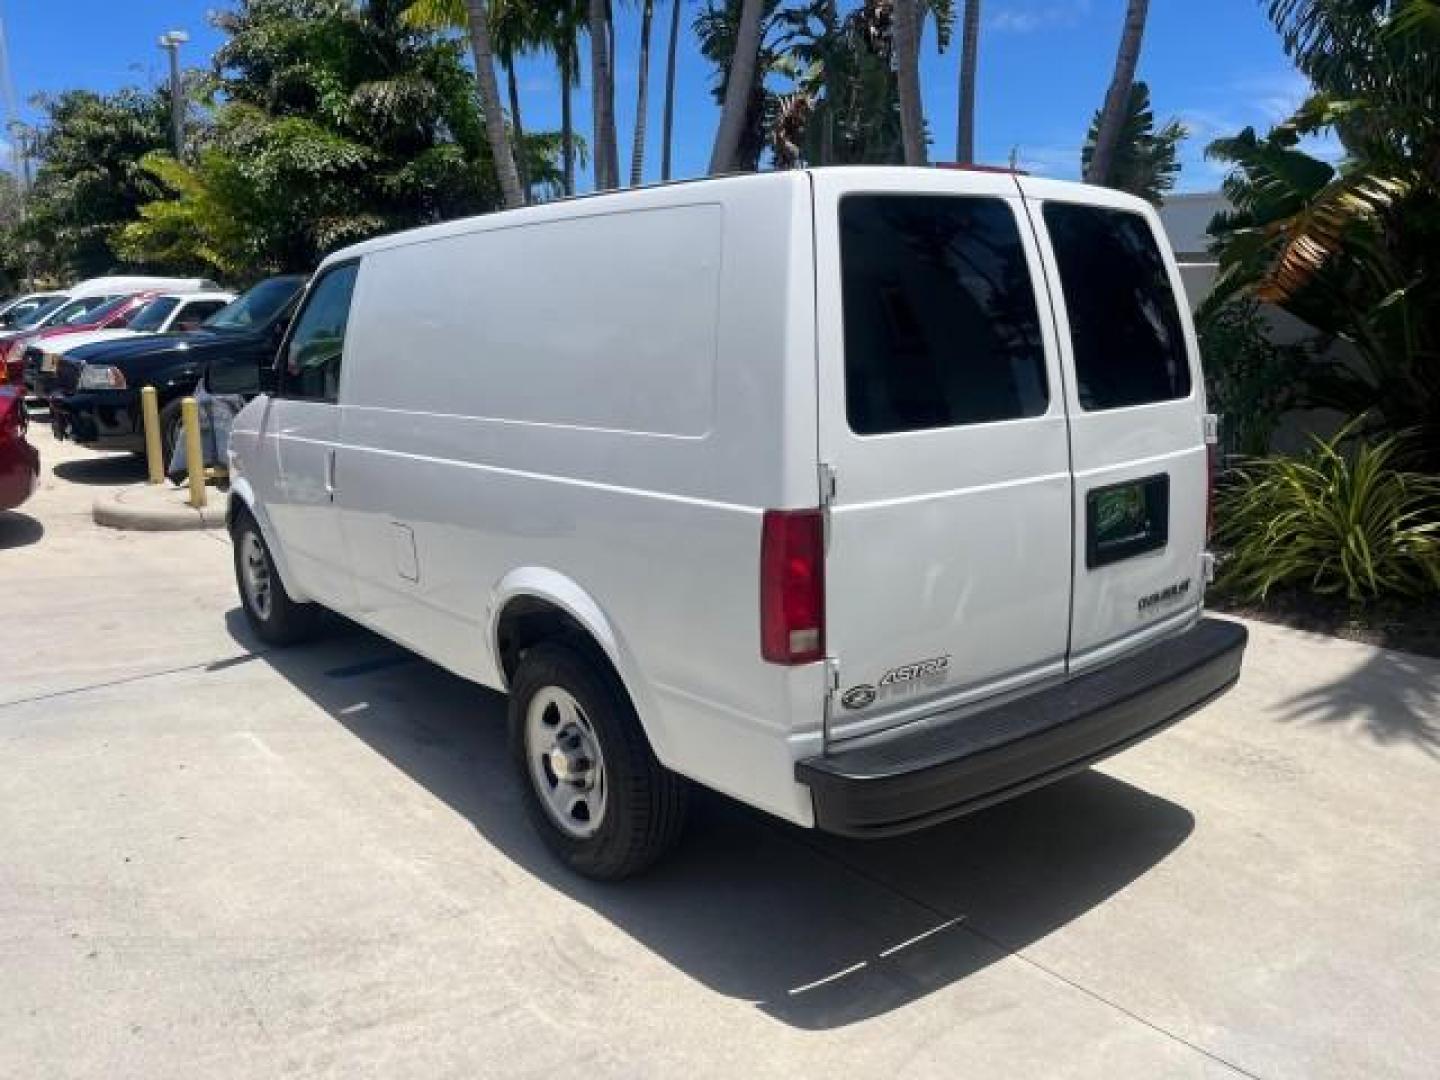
[317,166,1148,271]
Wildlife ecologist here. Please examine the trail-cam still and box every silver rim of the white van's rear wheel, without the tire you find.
[526,685,606,840]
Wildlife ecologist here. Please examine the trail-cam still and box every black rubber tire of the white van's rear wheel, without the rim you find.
[510,642,688,881]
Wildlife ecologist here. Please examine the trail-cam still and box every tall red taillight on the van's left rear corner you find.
[760,510,825,664]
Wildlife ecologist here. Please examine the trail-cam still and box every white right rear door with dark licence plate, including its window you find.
[1020,179,1210,671]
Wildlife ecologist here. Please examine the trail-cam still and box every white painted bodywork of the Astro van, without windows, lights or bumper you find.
[230,168,1205,825]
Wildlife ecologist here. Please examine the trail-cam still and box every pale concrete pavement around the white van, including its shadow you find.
[0,433,1440,1077]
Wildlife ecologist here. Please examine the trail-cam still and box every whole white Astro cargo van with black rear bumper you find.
[230,168,1246,877]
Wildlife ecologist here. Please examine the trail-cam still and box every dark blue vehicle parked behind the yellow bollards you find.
[49,275,305,461]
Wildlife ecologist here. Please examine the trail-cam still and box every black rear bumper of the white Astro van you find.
[795,619,1248,837]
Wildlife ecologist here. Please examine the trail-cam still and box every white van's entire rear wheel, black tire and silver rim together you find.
[510,642,687,881]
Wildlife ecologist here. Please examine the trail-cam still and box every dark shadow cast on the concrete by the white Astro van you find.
[228,611,1194,1030]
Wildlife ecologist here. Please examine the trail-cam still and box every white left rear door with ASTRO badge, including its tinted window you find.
[812,168,1073,739]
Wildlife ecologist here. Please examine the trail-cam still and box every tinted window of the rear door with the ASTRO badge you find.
[840,194,1050,435]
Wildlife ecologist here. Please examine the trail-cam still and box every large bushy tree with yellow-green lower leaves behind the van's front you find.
[120,0,559,279]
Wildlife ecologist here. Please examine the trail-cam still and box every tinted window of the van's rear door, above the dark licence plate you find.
[1045,203,1189,409]
